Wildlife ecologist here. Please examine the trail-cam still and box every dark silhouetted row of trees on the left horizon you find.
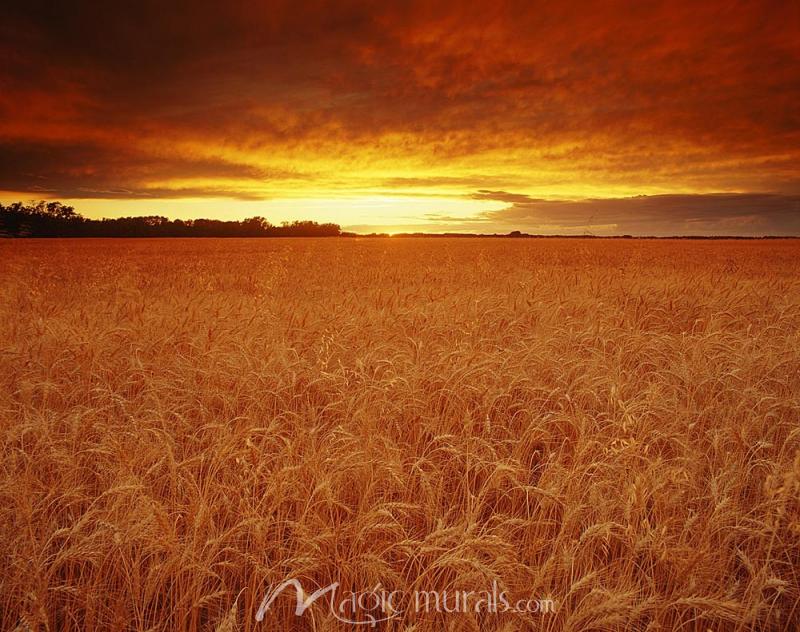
[0,201,342,237]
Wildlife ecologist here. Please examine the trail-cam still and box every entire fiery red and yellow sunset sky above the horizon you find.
[0,0,800,235]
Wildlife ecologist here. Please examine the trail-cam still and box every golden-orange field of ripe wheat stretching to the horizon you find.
[0,238,800,632]
